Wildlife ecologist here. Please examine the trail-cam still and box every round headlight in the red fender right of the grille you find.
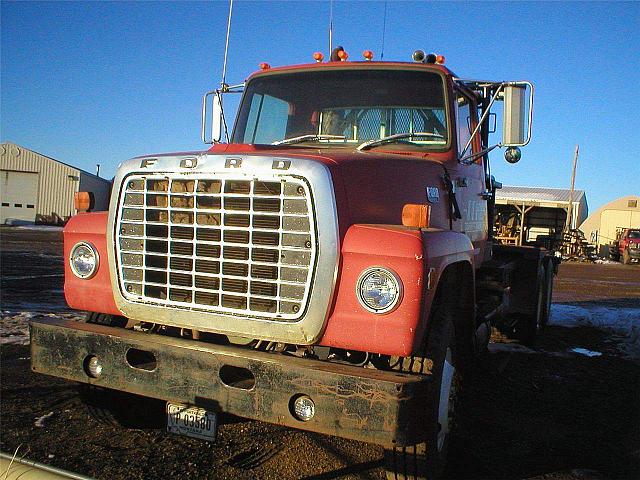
[356,267,402,313]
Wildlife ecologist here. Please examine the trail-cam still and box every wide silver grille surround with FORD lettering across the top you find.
[107,153,339,344]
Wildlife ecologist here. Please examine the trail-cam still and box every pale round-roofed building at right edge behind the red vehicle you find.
[580,195,640,257]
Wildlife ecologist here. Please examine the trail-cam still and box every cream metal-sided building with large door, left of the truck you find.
[0,143,111,224]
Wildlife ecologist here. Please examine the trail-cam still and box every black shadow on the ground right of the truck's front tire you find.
[446,322,640,479]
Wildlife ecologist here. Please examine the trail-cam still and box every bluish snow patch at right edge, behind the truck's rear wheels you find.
[549,302,640,358]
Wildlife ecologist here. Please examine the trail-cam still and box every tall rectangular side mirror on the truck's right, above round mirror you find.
[502,82,533,147]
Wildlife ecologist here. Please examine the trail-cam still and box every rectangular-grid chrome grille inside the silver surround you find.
[115,174,317,321]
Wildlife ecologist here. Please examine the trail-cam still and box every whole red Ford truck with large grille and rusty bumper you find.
[31,48,556,478]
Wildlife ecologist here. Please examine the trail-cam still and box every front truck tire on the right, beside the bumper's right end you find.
[385,294,461,480]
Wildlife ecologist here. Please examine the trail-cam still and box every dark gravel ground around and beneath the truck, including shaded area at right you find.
[0,228,640,480]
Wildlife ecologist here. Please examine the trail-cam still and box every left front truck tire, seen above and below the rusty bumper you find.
[79,312,165,429]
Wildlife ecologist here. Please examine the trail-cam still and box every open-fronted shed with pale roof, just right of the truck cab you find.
[495,185,588,245]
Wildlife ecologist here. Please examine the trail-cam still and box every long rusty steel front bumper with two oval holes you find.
[31,319,430,446]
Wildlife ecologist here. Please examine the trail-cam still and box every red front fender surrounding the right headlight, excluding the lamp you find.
[320,225,473,357]
